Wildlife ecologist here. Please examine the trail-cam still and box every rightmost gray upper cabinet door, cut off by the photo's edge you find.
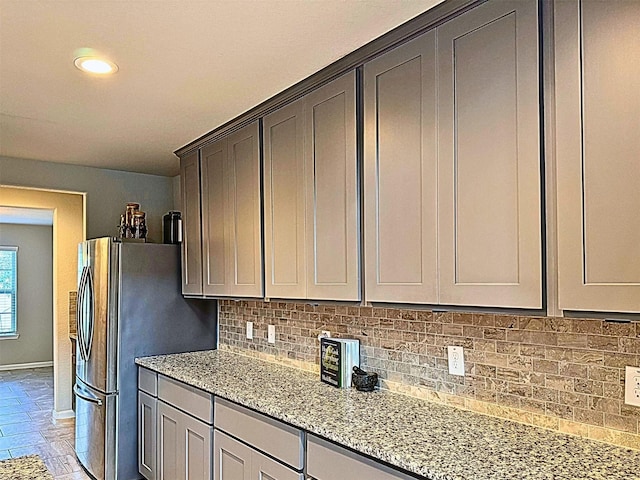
[554,0,640,312]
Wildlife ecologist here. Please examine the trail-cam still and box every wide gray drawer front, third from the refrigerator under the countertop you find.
[214,398,304,470]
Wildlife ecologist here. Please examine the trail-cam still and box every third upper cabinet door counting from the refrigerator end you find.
[226,123,262,297]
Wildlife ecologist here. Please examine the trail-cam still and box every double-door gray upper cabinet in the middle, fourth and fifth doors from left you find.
[263,72,360,300]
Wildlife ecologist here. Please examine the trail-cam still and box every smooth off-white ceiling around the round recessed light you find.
[0,0,442,176]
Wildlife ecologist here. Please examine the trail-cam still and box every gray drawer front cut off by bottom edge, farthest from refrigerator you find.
[307,435,413,480]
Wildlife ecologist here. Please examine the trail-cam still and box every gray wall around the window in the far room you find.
[0,223,53,366]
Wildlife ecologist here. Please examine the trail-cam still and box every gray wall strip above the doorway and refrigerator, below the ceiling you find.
[0,156,178,243]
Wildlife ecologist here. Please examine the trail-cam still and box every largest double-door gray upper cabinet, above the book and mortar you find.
[364,0,542,308]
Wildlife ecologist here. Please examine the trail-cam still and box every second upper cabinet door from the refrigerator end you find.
[201,140,229,295]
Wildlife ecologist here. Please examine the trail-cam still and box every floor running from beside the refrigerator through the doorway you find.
[0,368,91,480]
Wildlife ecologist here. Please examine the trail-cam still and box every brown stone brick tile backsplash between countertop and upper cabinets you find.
[219,300,640,449]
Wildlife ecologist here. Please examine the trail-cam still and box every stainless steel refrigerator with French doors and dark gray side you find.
[74,238,217,480]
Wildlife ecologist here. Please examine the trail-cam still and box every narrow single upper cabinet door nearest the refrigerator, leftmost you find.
[180,152,202,295]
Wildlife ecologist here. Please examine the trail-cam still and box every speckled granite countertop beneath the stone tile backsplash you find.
[136,350,640,480]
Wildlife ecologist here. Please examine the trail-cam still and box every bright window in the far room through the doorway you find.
[0,246,18,337]
